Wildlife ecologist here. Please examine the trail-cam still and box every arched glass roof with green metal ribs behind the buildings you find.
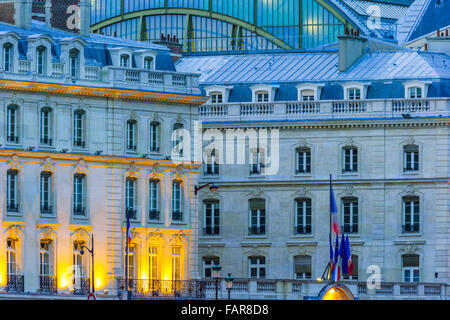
[91,0,409,52]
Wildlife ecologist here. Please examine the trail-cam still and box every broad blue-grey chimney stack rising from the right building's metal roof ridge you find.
[338,34,368,72]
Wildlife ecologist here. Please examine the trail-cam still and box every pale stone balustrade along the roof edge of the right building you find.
[199,97,450,122]
